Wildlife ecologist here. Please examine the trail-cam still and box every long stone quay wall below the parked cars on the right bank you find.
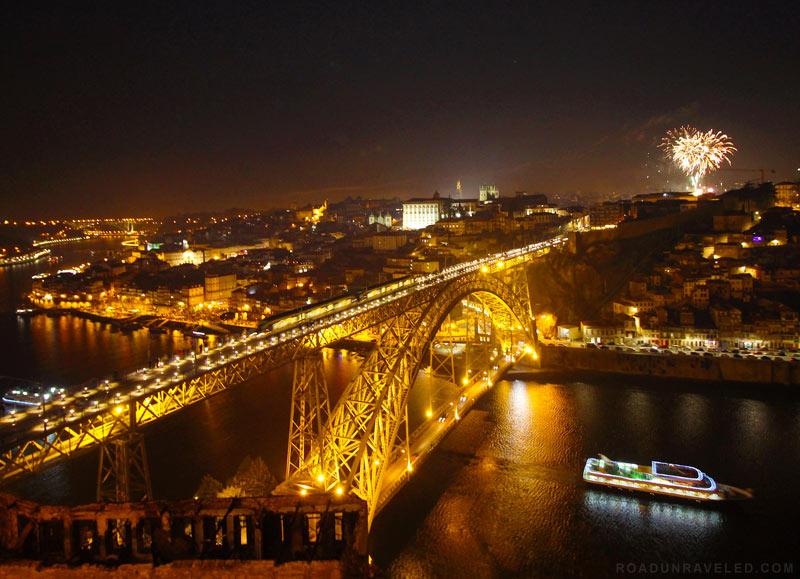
[539,344,800,386]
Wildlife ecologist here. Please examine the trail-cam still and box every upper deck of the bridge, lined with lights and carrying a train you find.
[0,236,566,479]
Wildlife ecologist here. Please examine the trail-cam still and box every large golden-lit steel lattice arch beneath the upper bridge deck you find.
[283,268,535,521]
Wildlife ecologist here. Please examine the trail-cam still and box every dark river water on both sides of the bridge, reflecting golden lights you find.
[0,240,800,577]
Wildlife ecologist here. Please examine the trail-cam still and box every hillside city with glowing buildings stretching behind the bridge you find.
[3,182,800,356]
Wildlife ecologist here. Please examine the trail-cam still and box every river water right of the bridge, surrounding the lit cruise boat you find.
[371,379,800,577]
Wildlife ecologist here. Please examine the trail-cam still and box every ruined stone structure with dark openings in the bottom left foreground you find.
[0,494,367,574]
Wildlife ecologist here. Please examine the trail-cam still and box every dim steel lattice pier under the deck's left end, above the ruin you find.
[97,403,153,503]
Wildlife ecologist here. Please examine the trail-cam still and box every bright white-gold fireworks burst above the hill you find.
[659,126,736,191]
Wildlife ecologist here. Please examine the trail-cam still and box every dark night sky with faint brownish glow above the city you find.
[0,0,800,218]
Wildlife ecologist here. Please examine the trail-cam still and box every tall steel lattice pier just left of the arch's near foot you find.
[286,350,330,479]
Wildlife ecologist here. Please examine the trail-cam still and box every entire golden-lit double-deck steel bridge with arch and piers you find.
[0,237,566,518]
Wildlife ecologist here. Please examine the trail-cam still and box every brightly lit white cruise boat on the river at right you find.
[583,454,753,501]
